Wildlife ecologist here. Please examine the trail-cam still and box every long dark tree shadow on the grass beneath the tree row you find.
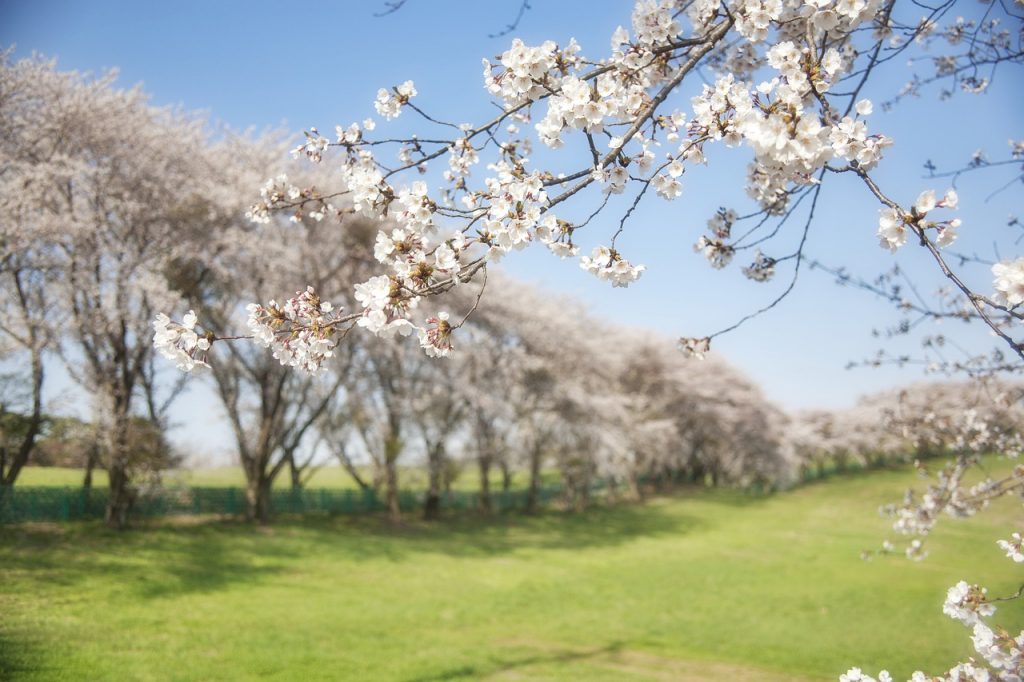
[0,493,765,598]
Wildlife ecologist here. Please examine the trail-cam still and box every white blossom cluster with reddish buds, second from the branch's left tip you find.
[246,287,338,374]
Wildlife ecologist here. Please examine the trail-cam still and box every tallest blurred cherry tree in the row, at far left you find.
[0,52,245,526]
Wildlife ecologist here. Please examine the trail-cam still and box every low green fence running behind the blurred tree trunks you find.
[0,484,577,523]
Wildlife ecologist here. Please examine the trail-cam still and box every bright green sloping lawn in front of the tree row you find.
[0,458,1024,682]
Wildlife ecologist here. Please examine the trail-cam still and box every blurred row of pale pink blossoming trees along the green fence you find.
[0,52,786,526]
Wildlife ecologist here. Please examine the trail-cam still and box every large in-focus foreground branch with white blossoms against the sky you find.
[153,0,1024,371]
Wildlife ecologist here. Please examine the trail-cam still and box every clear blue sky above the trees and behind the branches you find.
[0,0,1024,456]
